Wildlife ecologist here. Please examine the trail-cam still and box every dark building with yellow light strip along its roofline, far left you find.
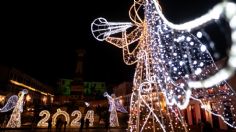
[0,66,54,107]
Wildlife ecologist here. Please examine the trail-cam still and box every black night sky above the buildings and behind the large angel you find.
[0,0,229,85]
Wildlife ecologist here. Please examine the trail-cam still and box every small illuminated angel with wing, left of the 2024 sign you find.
[0,89,28,128]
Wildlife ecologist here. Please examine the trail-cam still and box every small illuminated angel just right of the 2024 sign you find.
[104,92,128,127]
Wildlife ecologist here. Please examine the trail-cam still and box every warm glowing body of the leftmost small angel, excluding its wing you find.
[6,89,28,128]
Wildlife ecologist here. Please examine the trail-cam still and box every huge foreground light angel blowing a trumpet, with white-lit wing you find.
[91,0,236,131]
